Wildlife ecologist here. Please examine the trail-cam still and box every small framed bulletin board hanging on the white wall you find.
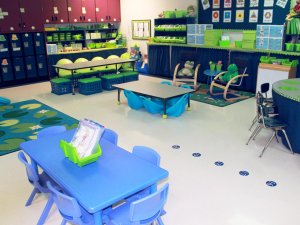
[131,20,151,40]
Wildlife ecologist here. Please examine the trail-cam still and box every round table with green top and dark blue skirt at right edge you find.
[272,78,300,153]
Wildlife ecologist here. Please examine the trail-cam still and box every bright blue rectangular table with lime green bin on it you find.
[21,130,168,225]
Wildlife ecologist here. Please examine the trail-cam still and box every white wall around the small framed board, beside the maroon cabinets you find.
[120,0,197,55]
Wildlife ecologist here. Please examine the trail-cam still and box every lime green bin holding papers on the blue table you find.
[59,140,102,167]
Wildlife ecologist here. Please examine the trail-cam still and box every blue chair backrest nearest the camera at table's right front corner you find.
[129,184,169,224]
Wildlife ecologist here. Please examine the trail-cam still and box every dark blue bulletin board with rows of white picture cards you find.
[198,0,294,30]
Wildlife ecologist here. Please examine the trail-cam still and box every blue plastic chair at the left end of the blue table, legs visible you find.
[18,152,58,224]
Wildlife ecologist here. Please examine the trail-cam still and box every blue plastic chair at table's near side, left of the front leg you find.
[47,182,95,225]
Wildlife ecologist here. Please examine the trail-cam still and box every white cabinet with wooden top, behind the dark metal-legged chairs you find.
[256,63,297,97]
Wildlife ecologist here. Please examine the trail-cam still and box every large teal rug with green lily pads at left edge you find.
[0,100,78,156]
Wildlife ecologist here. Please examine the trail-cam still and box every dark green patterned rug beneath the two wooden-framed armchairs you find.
[191,84,255,107]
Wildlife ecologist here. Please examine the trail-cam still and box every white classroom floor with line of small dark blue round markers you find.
[0,76,300,225]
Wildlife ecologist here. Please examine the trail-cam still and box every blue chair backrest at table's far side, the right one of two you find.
[132,146,160,166]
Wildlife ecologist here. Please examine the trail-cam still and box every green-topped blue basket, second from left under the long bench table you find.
[78,78,102,95]
